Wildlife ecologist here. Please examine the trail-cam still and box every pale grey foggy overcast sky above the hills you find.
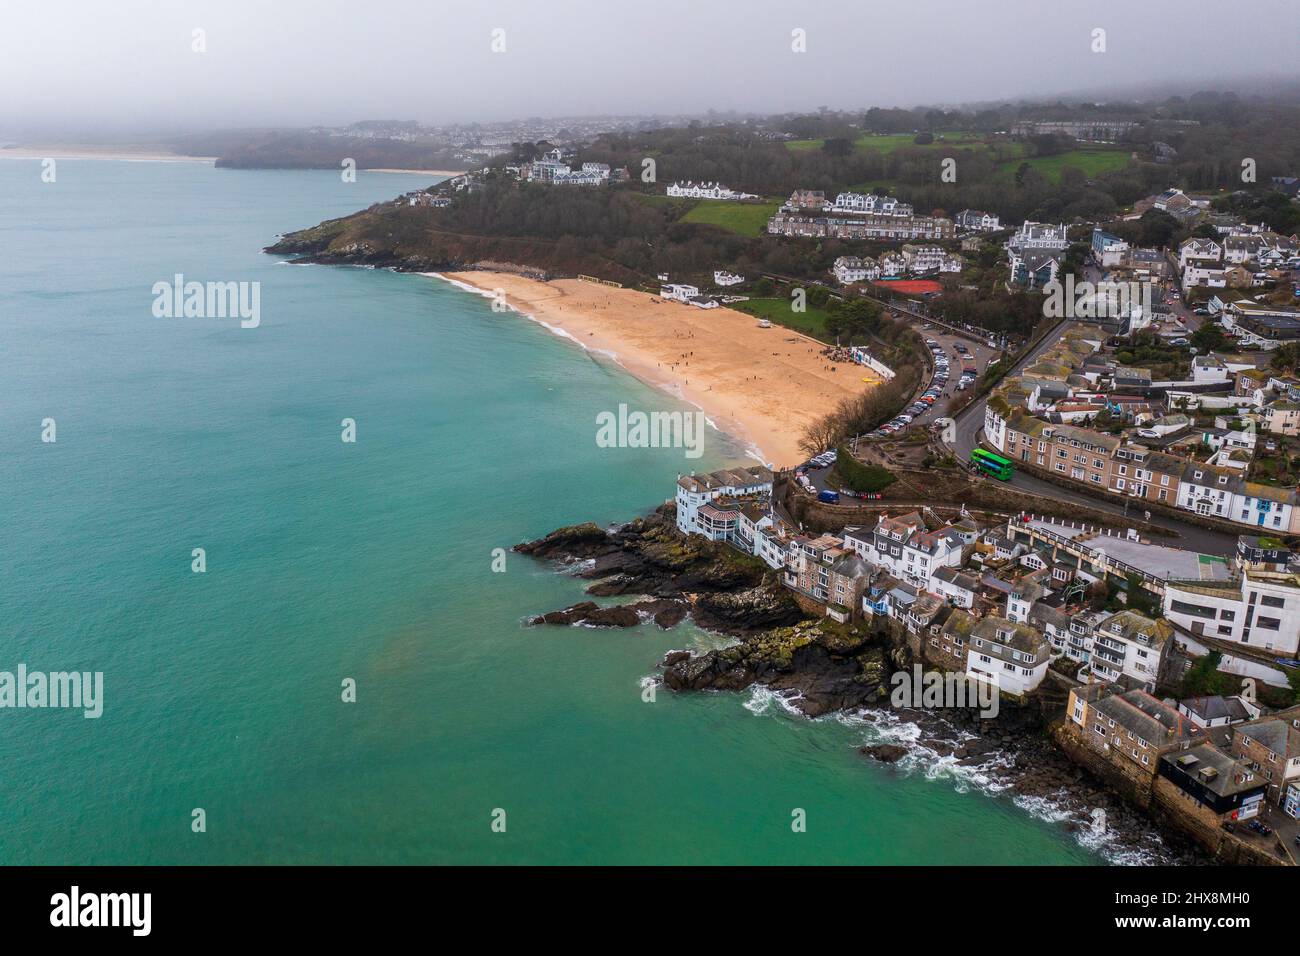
[0,0,1300,135]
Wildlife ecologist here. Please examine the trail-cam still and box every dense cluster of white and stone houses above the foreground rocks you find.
[673,457,1300,865]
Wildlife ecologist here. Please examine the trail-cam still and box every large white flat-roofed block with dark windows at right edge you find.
[1164,564,1300,657]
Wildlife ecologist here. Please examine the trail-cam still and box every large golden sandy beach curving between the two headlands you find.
[446,272,878,467]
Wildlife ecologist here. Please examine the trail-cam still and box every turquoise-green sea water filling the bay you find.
[0,160,1105,864]
